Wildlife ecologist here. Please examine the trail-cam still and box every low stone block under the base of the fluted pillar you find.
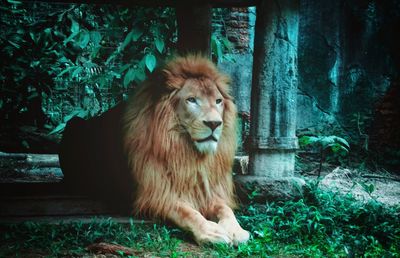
[234,175,305,203]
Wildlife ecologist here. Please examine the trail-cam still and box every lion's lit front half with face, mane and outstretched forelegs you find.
[122,55,250,245]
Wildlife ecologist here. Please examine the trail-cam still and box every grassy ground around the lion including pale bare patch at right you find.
[0,154,400,257]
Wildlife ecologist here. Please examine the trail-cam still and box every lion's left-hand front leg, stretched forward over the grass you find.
[168,202,232,244]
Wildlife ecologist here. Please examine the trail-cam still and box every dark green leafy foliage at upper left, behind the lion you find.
[0,0,176,133]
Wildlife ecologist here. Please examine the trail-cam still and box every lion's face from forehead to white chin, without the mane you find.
[177,76,224,153]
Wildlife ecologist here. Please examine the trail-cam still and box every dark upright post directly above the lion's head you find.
[176,4,212,57]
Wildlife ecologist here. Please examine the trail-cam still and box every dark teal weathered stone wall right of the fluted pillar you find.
[298,0,400,169]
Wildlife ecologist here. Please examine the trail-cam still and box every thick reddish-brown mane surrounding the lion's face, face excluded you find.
[123,56,236,218]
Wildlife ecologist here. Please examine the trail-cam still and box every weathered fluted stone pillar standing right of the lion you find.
[234,0,302,202]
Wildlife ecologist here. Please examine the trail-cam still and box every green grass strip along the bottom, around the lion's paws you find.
[0,182,400,257]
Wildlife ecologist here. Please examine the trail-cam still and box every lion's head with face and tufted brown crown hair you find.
[163,56,234,154]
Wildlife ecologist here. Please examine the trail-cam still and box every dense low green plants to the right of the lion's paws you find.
[242,181,400,257]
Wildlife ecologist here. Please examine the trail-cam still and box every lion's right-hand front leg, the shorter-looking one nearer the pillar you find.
[211,201,250,245]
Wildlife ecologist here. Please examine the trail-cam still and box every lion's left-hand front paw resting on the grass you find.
[193,221,232,244]
